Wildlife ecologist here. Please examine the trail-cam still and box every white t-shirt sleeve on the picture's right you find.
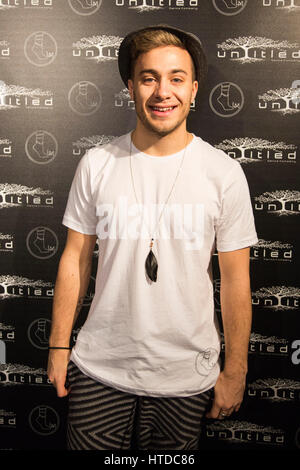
[215,164,258,251]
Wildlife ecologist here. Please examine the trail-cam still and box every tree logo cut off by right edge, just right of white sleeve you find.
[254,189,300,217]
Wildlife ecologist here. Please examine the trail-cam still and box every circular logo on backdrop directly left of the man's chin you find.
[68,81,102,116]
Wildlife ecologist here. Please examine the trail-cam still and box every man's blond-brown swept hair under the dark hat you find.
[130,29,196,80]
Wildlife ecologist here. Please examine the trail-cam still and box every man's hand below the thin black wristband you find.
[47,349,71,397]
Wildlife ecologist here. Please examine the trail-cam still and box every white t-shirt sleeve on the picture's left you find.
[62,151,97,235]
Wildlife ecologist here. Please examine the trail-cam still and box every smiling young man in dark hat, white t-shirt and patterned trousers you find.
[48,25,257,450]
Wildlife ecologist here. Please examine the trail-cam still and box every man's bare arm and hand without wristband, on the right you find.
[207,248,252,419]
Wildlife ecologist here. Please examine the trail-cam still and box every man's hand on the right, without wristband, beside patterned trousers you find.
[206,372,245,419]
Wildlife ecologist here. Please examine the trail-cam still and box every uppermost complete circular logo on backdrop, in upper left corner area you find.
[24,31,57,67]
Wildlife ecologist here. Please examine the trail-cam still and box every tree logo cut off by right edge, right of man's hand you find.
[247,378,300,402]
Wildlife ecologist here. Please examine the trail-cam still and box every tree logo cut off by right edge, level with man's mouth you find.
[258,85,300,116]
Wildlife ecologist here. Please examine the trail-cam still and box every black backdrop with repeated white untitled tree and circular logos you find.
[0,0,300,450]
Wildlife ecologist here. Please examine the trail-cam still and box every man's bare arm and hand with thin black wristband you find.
[47,229,97,397]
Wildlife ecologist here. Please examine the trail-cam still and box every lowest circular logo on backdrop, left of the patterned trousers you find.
[28,405,60,436]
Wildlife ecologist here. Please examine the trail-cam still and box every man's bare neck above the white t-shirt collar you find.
[131,127,193,157]
